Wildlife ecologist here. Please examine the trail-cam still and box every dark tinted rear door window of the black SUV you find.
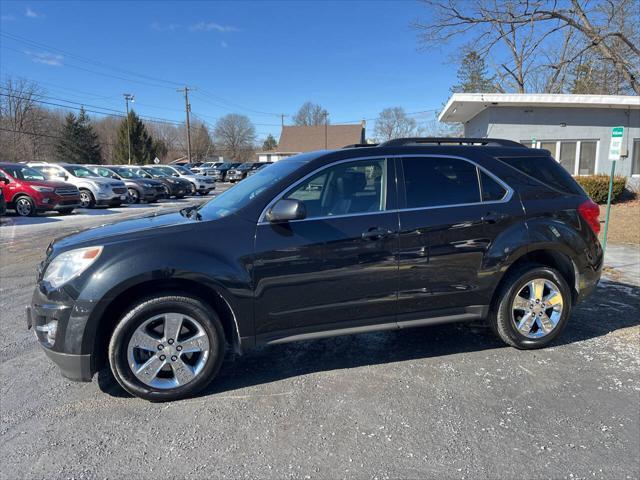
[402,157,480,208]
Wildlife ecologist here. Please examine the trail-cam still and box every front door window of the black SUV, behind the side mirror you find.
[284,159,387,218]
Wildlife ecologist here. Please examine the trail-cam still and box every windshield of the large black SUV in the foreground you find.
[199,159,305,220]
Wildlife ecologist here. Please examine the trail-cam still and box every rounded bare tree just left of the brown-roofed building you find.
[213,113,256,161]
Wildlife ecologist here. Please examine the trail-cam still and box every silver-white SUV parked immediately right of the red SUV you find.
[27,162,127,208]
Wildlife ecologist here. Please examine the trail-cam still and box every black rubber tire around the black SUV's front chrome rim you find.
[109,294,225,402]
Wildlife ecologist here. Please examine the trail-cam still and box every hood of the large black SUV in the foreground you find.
[52,212,194,251]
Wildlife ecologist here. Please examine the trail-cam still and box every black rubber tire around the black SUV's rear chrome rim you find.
[488,264,572,350]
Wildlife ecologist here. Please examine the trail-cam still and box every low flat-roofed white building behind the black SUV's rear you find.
[439,93,640,180]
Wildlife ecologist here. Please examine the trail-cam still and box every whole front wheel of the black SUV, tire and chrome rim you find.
[109,295,225,401]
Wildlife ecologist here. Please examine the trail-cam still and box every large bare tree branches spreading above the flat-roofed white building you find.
[415,0,640,94]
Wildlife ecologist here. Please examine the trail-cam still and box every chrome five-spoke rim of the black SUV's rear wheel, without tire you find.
[511,278,564,338]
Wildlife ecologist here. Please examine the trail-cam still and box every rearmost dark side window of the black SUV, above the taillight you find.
[498,155,585,195]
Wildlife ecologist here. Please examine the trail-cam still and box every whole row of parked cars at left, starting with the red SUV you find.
[0,162,215,216]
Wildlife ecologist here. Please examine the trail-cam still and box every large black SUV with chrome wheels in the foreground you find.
[27,139,603,401]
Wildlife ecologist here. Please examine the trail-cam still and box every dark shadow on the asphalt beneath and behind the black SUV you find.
[98,280,640,396]
